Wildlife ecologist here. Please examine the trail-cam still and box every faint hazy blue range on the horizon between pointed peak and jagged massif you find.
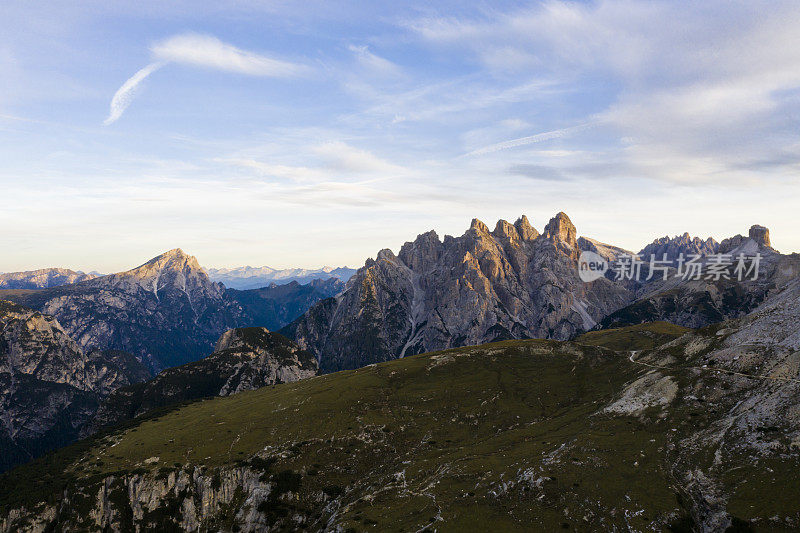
[207,266,356,290]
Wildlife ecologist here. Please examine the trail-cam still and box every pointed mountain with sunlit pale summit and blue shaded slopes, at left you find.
[0,249,340,373]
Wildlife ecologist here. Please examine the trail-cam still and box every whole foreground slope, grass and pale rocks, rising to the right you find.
[0,314,800,531]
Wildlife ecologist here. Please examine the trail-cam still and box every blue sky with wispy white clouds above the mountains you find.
[0,0,800,272]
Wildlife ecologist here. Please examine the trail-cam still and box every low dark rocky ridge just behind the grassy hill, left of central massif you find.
[92,328,318,434]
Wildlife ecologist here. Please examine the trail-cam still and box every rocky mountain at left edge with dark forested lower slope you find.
[0,300,150,470]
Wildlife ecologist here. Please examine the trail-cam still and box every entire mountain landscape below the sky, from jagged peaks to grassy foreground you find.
[0,213,800,531]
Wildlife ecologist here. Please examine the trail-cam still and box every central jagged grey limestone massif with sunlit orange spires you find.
[283,213,632,371]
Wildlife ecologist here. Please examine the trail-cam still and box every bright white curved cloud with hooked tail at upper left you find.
[103,33,309,126]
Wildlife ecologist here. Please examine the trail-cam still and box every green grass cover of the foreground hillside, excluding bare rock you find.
[0,325,797,531]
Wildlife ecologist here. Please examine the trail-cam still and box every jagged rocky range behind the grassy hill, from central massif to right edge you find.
[282,213,780,371]
